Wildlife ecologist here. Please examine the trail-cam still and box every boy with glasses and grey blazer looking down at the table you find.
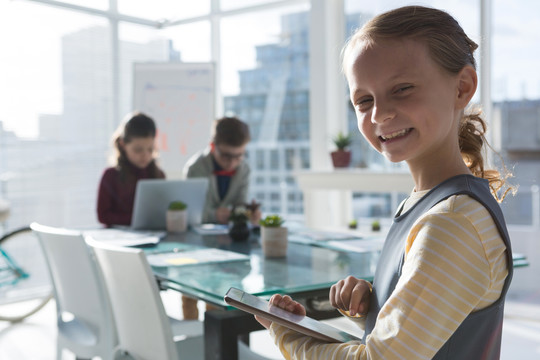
[184,117,261,224]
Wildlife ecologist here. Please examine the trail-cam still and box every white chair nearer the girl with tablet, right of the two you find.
[87,238,204,360]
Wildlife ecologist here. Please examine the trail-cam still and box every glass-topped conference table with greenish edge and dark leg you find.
[145,231,382,360]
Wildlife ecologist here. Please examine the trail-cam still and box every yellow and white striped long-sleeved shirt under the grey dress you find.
[270,191,508,360]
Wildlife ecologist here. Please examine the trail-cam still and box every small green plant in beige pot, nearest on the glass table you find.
[259,214,287,257]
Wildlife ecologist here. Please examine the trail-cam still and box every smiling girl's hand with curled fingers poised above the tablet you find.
[330,276,371,316]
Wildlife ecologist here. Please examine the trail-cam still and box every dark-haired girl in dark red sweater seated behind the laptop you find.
[97,112,165,226]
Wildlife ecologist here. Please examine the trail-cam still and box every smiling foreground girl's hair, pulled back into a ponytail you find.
[342,6,514,201]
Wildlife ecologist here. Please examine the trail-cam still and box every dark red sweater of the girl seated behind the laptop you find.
[97,166,165,226]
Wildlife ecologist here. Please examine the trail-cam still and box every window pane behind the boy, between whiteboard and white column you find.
[221,1,309,217]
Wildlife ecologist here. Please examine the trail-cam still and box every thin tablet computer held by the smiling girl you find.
[223,287,361,342]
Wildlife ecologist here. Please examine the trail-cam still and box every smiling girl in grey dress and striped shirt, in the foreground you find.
[258,6,512,360]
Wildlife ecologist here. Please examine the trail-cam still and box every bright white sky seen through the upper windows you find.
[0,0,540,137]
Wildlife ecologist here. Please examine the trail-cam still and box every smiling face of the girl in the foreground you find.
[345,39,463,165]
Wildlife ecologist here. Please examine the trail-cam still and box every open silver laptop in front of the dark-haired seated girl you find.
[131,178,208,230]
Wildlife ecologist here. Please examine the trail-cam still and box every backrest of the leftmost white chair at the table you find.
[30,223,118,360]
